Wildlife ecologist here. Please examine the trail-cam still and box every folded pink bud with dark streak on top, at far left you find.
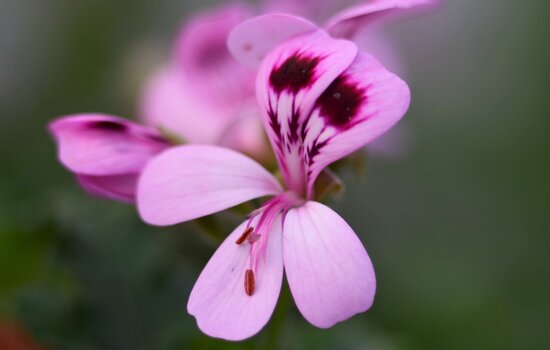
[49,114,169,203]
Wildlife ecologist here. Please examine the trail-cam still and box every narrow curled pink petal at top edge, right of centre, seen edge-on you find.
[325,0,439,38]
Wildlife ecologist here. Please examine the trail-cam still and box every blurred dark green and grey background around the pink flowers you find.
[0,0,550,350]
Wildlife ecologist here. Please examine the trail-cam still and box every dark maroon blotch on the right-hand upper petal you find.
[317,75,367,129]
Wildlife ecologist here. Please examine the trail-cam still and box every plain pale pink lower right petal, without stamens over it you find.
[283,202,376,328]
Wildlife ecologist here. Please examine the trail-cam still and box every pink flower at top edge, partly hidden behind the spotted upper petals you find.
[232,0,440,159]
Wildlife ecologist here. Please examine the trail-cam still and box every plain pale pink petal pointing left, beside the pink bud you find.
[138,145,281,226]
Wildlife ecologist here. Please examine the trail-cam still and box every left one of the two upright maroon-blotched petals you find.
[256,30,357,194]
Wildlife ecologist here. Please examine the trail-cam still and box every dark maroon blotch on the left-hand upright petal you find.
[269,52,321,94]
